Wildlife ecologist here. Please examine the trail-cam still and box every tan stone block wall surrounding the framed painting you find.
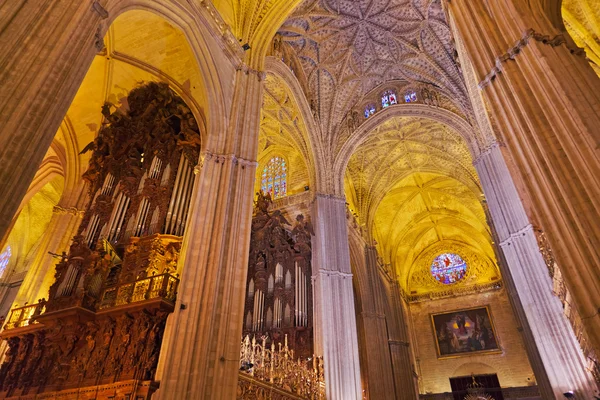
[409,289,535,394]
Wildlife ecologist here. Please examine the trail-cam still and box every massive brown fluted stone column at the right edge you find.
[447,0,600,352]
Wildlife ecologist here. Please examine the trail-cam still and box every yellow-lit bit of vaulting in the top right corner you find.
[562,0,600,76]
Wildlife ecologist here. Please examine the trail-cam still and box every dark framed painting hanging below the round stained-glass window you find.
[431,306,501,358]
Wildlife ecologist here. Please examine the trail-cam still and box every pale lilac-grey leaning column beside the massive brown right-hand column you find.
[474,144,596,399]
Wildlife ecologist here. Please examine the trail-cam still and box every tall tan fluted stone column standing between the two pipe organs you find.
[156,71,262,400]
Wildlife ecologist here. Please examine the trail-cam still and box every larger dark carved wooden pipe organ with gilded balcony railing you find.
[0,83,203,400]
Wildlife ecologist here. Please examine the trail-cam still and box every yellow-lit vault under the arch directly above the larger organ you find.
[65,10,206,158]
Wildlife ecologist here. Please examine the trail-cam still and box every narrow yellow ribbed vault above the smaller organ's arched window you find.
[256,74,312,194]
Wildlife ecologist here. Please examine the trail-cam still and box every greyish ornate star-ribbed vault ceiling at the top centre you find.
[279,0,467,144]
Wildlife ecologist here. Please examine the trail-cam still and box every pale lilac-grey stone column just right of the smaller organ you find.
[312,194,362,400]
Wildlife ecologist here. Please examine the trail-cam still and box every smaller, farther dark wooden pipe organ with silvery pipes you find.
[244,193,313,358]
